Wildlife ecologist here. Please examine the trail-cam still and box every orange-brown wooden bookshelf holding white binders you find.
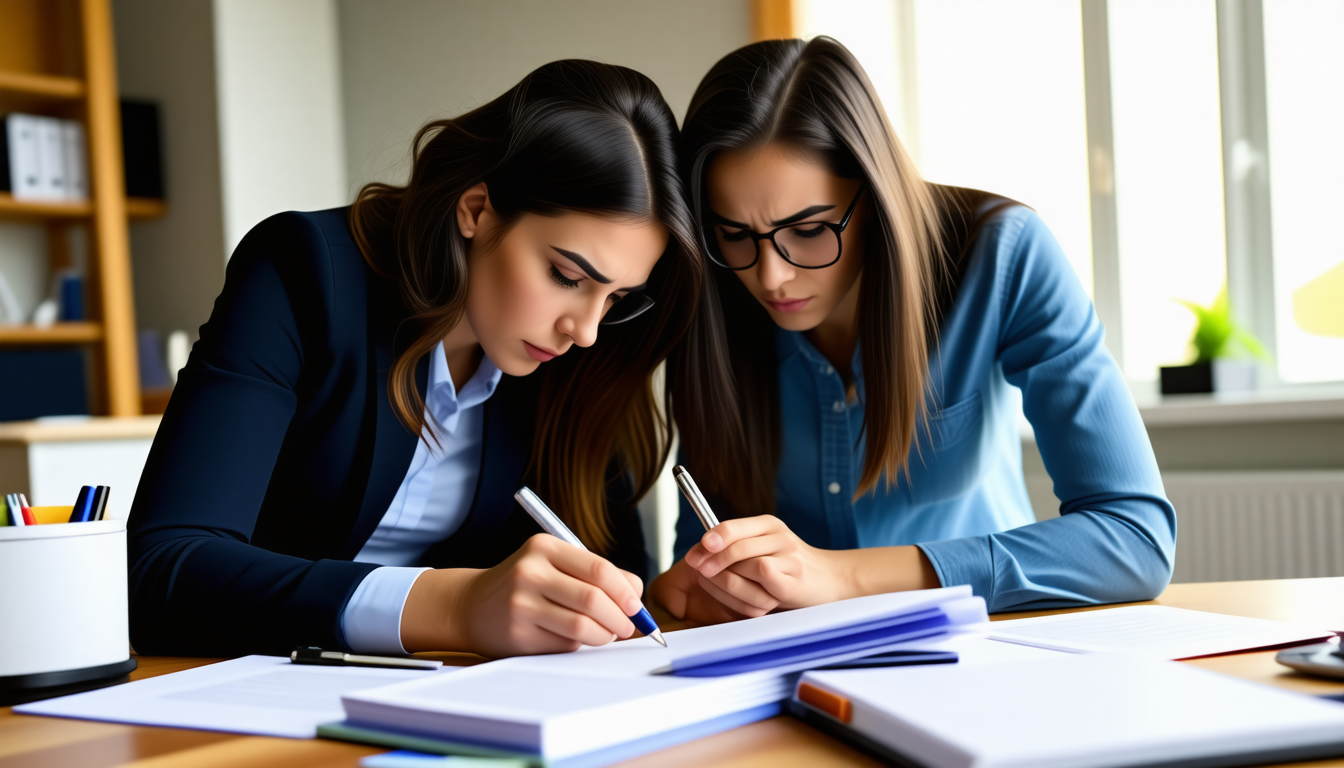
[0,0,148,416]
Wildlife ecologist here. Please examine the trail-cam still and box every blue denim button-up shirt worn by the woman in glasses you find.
[676,207,1176,611]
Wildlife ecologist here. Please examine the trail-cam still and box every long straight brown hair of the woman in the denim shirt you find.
[668,36,982,514]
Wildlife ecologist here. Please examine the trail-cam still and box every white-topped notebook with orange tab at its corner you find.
[789,654,1344,768]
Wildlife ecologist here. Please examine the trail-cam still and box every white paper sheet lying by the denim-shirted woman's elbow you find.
[989,605,1335,659]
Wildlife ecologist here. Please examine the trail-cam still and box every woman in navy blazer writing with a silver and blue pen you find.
[129,61,702,655]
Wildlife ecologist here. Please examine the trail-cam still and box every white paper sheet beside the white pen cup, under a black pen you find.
[13,656,457,738]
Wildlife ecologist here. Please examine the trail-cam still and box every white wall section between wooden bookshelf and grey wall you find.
[214,0,348,254]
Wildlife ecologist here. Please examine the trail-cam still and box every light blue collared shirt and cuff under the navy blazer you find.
[341,343,503,654]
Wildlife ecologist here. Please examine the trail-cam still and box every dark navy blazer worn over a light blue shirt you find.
[128,208,648,655]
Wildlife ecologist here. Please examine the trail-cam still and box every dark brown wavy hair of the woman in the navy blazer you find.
[349,61,704,551]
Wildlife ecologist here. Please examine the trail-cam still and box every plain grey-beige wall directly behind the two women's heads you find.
[340,0,751,196]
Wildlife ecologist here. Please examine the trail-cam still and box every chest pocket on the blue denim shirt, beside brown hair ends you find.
[900,391,984,507]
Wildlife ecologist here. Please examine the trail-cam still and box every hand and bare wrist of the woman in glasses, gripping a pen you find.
[685,515,939,616]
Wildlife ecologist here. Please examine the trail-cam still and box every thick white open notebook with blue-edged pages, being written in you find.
[343,586,986,765]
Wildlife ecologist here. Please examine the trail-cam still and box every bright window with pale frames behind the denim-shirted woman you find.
[793,0,1344,385]
